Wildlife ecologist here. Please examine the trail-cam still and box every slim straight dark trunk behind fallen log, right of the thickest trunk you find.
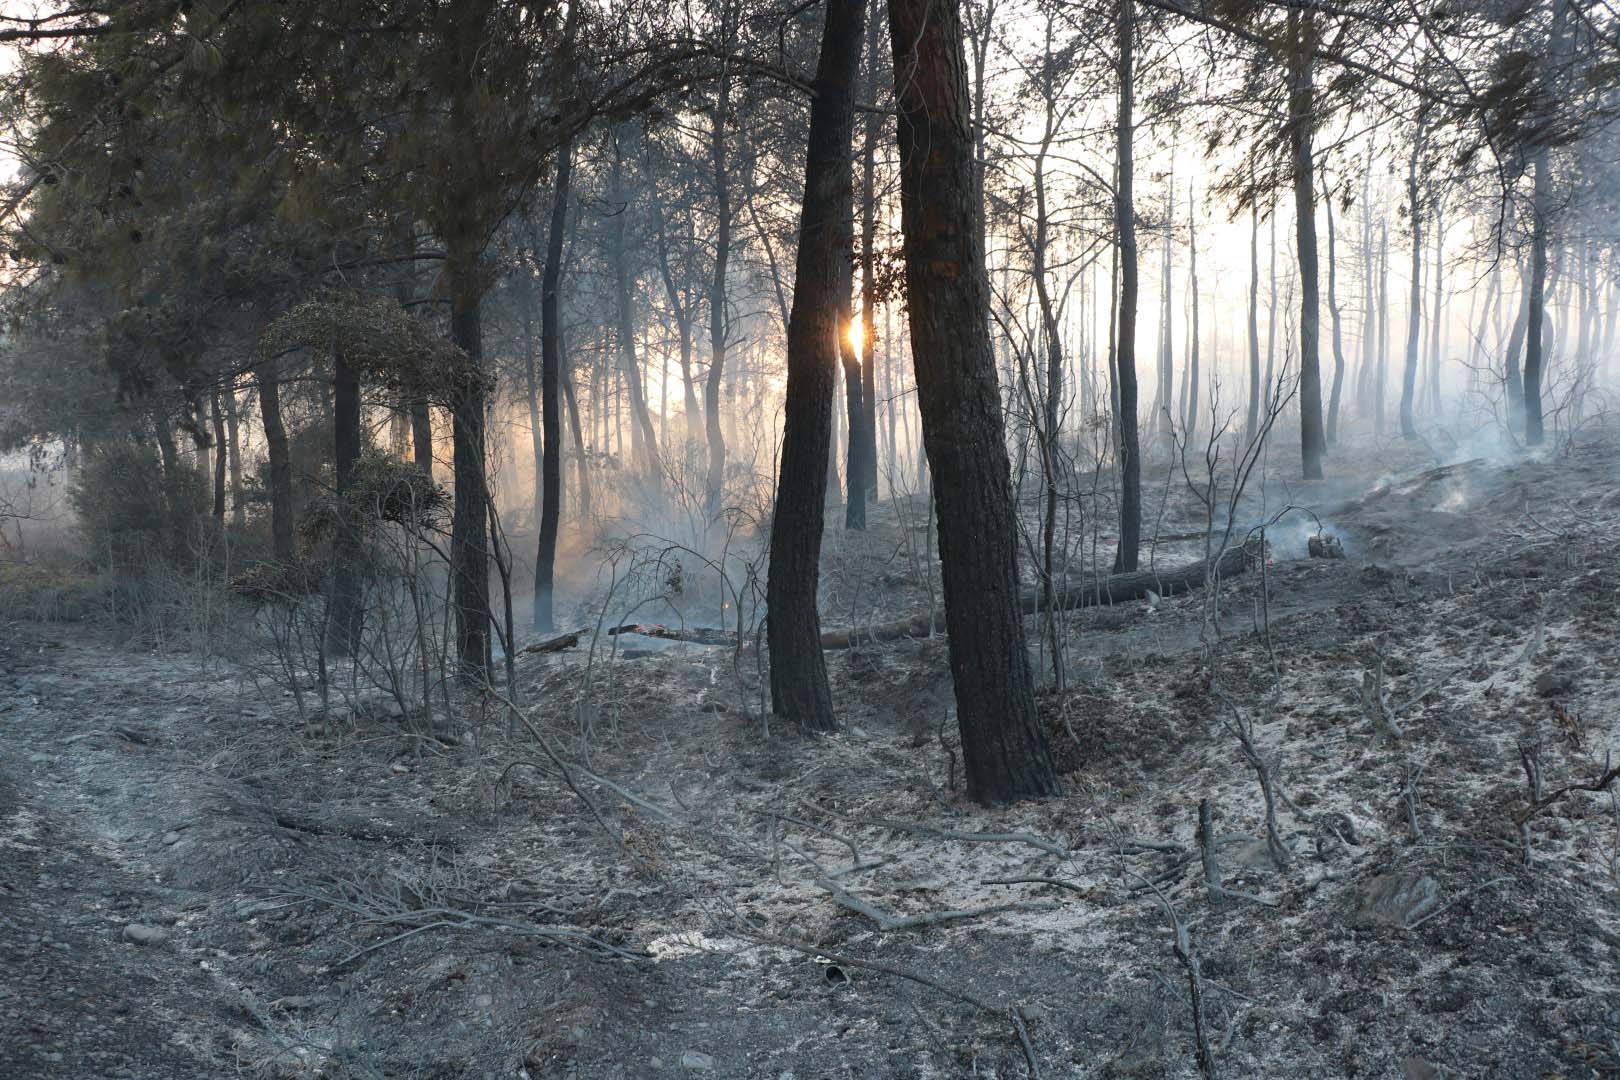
[1110,0,1142,573]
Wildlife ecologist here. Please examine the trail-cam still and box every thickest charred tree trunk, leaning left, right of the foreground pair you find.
[889,0,1058,803]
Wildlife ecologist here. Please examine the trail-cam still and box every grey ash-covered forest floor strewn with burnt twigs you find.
[0,439,1620,1080]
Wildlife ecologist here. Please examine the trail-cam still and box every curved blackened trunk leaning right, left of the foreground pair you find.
[766,0,863,732]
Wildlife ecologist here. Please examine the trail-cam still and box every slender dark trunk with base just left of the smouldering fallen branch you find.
[535,142,585,631]
